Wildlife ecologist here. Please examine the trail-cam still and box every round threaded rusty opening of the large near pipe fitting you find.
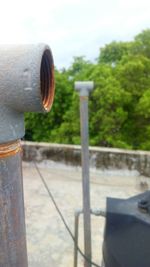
[40,49,55,111]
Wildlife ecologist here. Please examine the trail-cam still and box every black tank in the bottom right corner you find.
[103,191,150,267]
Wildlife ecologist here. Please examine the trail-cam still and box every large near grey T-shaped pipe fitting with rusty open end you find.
[0,44,54,143]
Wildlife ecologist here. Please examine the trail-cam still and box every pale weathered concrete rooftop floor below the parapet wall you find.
[23,162,150,267]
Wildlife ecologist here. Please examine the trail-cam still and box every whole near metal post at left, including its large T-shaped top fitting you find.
[0,44,54,267]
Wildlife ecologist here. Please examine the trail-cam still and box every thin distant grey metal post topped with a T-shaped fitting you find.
[75,82,94,267]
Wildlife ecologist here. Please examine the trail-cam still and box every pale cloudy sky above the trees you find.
[0,0,150,69]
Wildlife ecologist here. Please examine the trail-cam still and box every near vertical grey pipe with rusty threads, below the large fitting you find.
[0,141,28,267]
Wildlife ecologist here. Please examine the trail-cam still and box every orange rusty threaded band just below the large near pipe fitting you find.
[0,140,22,159]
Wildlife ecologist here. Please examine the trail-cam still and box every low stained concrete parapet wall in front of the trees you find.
[23,142,150,176]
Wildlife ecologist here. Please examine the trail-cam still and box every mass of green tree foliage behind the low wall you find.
[26,29,150,149]
